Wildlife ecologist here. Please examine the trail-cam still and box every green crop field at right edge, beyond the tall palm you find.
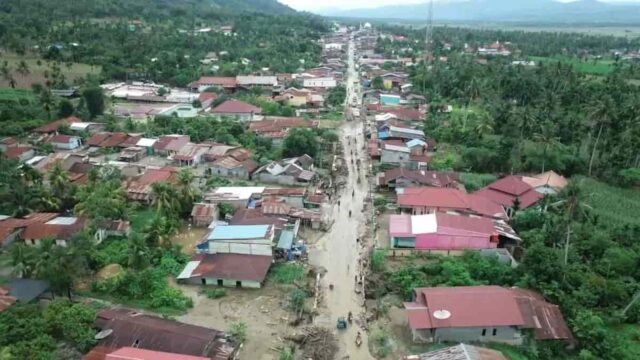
[573,177,640,225]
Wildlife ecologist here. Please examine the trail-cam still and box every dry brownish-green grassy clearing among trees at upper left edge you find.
[0,53,101,89]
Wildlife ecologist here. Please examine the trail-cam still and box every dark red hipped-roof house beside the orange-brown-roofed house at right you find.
[474,175,544,214]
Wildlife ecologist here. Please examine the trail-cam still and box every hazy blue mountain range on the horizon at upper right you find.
[322,0,640,23]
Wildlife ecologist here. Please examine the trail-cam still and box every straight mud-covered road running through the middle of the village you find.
[309,34,373,359]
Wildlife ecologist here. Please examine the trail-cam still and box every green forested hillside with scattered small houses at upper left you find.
[0,0,326,87]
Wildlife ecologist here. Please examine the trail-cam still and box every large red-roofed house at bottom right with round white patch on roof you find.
[404,286,573,345]
